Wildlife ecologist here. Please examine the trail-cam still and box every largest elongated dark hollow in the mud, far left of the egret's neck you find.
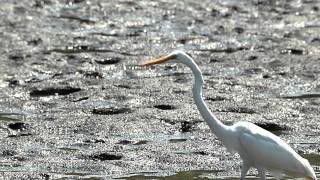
[30,86,81,97]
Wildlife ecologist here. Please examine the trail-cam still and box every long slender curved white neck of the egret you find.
[188,63,228,140]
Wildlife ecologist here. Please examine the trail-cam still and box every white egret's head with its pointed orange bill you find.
[142,50,194,66]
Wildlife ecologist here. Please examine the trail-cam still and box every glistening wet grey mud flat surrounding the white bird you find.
[0,0,320,179]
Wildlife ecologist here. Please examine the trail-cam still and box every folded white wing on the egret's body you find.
[240,130,304,174]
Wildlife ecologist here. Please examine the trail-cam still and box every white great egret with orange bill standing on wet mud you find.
[142,50,316,180]
